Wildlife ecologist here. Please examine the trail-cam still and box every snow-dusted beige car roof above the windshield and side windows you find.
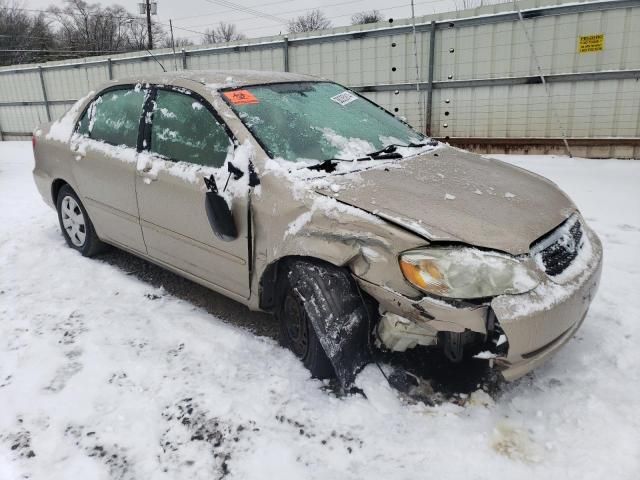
[111,70,321,90]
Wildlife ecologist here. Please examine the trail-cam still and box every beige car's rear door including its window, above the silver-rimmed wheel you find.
[70,85,147,253]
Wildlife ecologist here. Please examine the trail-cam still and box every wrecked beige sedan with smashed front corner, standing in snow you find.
[33,71,602,385]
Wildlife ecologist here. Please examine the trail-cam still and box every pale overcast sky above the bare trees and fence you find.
[21,0,480,43]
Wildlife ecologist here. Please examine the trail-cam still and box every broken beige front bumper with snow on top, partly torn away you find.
[356,228,602,381]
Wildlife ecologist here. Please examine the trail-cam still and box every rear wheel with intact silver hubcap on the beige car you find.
[56,185,106,257]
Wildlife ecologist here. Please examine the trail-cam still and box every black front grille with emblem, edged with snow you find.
[533,215,584,277]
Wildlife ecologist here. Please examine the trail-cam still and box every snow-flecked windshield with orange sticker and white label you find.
[223,82,426,162]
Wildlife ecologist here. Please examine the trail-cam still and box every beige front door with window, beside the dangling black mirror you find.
[136,88,249,299]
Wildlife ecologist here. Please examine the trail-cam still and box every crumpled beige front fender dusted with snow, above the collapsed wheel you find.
[250,175,427,309]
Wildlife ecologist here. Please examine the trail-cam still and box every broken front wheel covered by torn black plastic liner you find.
[276,259,370,386]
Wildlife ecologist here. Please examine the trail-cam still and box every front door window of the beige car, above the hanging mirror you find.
[150,90,231,167]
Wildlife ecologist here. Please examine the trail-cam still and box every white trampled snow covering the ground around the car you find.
[0,142,640,480]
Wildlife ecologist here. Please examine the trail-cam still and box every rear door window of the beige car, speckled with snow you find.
[77,88,145,148]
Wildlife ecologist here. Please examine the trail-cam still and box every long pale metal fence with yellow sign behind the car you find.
[0,0,640,158]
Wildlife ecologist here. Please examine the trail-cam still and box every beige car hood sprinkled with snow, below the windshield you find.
[316,147,576,255]
